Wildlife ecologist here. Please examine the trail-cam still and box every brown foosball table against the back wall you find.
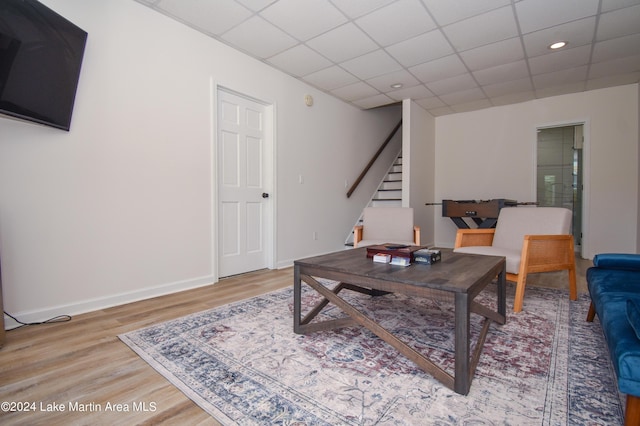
[427,198,524,229]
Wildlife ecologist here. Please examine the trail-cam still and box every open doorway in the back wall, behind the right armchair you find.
[536,124,584,252]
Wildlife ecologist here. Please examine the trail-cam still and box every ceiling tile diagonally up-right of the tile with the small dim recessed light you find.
[386,30,453,67]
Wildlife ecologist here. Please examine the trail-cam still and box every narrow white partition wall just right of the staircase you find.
[402,99,436,245]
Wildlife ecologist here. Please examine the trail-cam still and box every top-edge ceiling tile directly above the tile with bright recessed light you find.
[515,0,599,34]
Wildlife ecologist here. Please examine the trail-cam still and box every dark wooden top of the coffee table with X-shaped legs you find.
[294,247,505,293]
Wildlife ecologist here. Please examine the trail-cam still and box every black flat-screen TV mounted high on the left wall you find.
[0,0,87,131]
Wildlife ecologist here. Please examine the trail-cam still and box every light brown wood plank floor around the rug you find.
[0,260,591,425]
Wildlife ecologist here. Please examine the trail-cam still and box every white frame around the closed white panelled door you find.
[210,83,277,282]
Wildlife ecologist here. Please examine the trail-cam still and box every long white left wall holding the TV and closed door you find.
[0,0,401,326]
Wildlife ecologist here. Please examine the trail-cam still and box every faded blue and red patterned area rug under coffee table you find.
[120,282,623,425]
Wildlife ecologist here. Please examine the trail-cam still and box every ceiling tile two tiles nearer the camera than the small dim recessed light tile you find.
[307,23,378,62]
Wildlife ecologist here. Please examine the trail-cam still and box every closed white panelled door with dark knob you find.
[218,90,271,277]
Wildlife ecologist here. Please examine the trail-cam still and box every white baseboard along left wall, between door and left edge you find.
[3,276,217,330]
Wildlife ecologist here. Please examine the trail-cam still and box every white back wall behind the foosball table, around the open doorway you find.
[435,84,638,258]
